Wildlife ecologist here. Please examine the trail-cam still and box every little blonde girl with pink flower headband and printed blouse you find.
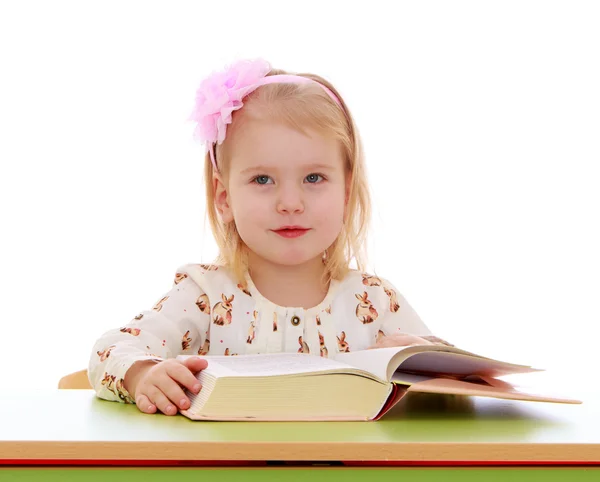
[88,60,444,415]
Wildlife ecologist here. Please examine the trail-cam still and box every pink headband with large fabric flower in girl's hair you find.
[188,59,342,171]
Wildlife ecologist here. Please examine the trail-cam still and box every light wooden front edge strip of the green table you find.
[0,441,600,463]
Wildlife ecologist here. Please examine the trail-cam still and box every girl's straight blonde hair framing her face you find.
[204,69,371,284]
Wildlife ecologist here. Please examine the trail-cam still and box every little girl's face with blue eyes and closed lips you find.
[215,120,350,266]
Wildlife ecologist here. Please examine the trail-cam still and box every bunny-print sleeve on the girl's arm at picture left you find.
[88,273,210,403]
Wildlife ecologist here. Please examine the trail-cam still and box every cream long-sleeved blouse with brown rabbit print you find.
[88,264,431,403]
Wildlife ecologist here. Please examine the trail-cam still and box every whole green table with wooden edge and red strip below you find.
[0,390,600,482]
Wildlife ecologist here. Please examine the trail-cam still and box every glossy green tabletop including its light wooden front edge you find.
[0,384,600,463]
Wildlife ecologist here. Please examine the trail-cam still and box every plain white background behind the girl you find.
[0,0,600,387]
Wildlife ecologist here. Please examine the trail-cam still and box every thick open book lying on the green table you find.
[178,345,581,421]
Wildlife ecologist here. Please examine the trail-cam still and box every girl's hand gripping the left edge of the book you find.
[124,357,208,415]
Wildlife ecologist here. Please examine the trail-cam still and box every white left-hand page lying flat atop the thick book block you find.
[178,353,354,377]
